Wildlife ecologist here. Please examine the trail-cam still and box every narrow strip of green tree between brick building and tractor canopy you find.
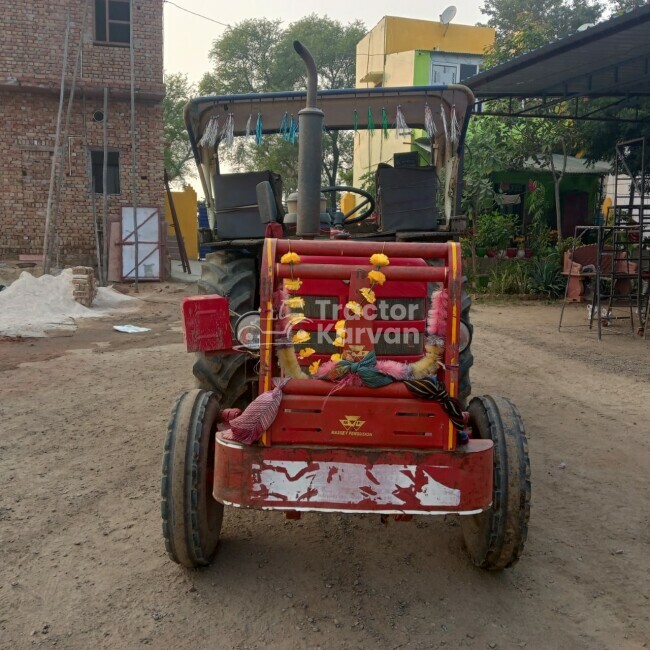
[163,73,195,181]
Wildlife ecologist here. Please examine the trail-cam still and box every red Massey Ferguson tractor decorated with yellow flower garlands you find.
[162,43,530,570]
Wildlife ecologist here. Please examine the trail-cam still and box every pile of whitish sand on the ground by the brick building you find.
[0,269,139,337]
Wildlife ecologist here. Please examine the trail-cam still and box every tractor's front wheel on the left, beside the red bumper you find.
[161,389,223,568]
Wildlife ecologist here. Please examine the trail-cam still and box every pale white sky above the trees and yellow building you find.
[165,0,485,83]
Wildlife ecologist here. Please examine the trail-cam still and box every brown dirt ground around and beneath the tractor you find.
[0,285,650,650]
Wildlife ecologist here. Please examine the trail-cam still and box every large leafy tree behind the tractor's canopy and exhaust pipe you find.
[199,14,366,192]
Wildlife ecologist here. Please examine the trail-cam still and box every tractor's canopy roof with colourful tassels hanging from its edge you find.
[185,84,474,162]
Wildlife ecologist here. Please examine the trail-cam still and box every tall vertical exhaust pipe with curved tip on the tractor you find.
[293,41,325,239]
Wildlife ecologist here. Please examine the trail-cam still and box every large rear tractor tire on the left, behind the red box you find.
[193,250,258,409]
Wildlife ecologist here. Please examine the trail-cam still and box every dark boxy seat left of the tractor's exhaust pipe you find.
[214,170,284,239]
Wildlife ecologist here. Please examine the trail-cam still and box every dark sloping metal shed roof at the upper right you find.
[464,5,650,100]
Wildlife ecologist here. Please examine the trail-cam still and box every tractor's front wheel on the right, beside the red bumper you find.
[460,395,530,571]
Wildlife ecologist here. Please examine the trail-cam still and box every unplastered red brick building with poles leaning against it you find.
[0,0,164,265]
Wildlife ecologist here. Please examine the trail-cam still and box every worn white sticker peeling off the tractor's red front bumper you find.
[251,460,461,507]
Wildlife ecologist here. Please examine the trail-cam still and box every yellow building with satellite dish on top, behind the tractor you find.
[354,16,495,187]
